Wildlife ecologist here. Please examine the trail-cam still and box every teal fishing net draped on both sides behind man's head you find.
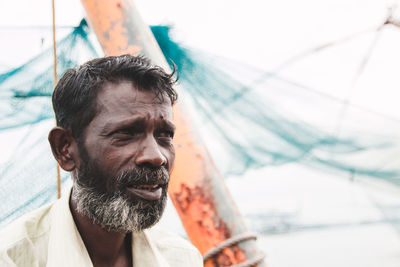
[0,18,400,228]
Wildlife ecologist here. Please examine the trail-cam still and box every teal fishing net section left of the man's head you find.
[0,21,98,227]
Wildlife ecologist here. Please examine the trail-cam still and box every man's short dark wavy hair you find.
[52,55,178,139]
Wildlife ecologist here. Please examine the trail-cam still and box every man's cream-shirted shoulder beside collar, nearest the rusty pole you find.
[146,227,203,266]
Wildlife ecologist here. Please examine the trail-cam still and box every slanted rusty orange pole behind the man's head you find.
[81,0,264,266]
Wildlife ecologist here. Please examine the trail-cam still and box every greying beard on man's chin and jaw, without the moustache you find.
[72,170,167,232]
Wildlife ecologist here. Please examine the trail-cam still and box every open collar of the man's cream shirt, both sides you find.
[47,190,169,267]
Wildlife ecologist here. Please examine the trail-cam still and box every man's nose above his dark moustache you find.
[135,136,167,167]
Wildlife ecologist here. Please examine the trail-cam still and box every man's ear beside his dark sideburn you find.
[48,127,79,172]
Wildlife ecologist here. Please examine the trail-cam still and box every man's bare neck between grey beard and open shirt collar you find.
[69,197,132,267]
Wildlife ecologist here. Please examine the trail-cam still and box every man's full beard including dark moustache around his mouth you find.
[72,154,169,232]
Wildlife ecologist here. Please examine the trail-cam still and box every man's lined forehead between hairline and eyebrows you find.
[95,81,172,119]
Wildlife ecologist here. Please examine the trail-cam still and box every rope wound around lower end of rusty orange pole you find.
[203,233,265,267]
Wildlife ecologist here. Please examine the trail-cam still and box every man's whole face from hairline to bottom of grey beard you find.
[73,81,175,232]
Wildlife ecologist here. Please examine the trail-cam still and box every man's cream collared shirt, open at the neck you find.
[0,189,203,267]
